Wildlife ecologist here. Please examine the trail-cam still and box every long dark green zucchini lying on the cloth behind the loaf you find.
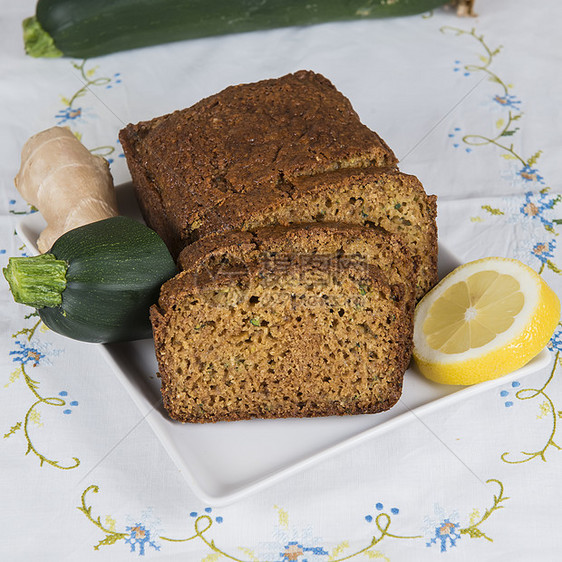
[24,0,448,58]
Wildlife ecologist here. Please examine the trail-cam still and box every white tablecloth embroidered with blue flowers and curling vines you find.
[0,0,562,562]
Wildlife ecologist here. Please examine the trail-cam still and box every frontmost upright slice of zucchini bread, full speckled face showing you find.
[151,256,413,422]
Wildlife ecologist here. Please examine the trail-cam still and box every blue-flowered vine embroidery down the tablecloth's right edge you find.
[441,26,562,464]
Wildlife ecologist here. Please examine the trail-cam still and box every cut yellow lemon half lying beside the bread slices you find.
[414,258,560,385]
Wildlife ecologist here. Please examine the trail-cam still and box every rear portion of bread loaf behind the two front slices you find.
[120,71,437,296]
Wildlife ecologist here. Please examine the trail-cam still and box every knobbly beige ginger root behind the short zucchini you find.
[15,127,118,253]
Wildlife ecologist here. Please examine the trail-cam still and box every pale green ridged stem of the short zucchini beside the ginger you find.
[3,254,68,308]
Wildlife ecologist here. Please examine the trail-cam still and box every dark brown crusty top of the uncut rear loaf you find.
[120,70,397,244]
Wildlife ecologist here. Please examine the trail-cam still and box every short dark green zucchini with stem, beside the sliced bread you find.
[4,217,176,343]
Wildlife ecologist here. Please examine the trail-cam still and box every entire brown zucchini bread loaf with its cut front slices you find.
[120,71,437,422]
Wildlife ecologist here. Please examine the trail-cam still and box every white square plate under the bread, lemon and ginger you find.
[17,191,550,506]
